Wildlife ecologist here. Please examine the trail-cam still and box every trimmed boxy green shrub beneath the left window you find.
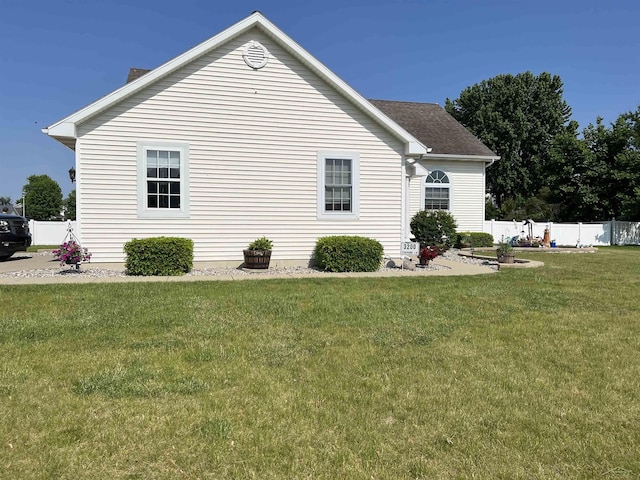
[124,237,193,276]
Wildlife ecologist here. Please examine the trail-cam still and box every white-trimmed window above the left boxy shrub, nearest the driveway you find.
[138,142,189,218]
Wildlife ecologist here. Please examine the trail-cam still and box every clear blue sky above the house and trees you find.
[0,0,640,201]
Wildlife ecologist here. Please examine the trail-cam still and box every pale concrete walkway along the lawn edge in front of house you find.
[0,252,496,285]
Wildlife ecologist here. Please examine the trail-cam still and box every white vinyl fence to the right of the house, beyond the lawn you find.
[483,220,640,247]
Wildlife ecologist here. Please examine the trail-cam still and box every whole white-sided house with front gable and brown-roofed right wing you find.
[43,12,497,265]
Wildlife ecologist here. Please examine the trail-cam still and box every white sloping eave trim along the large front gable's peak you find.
[43,12,427,156]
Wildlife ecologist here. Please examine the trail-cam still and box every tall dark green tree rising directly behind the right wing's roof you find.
[445,72,571,207]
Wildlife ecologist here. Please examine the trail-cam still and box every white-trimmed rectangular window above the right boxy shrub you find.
[318,152,359,220]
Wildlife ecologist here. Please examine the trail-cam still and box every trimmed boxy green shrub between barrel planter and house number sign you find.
[314,236,384,272]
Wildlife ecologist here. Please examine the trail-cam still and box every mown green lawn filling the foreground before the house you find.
[0,248,640,479]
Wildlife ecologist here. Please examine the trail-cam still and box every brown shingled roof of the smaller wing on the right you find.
[369,100,498,160]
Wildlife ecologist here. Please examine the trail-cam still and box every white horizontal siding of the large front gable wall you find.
[77,29,404,264]
